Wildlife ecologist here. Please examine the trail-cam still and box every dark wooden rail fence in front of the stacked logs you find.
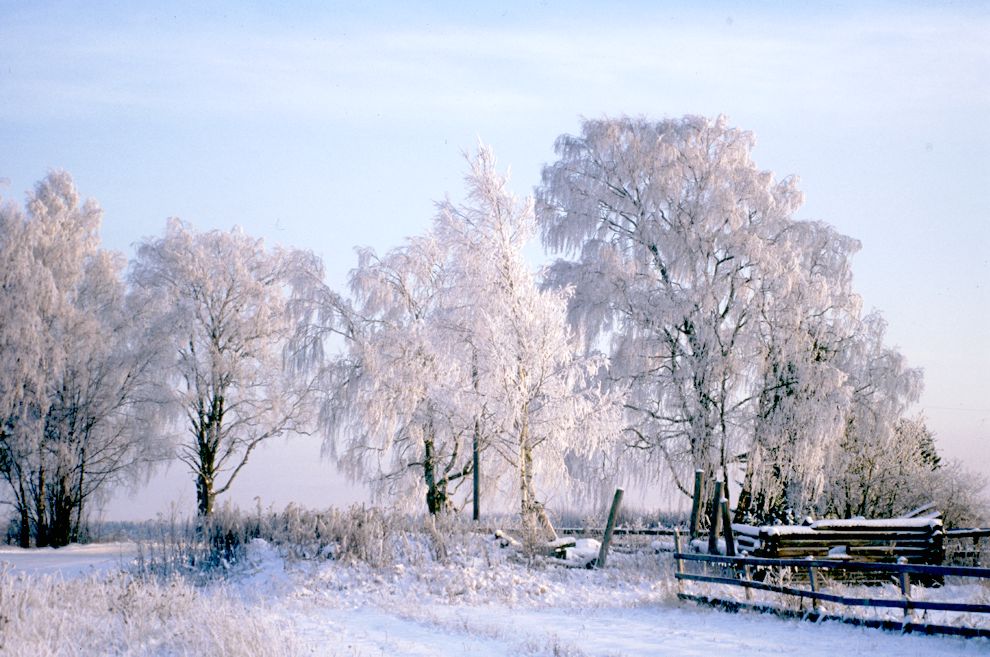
[674,537,990,638]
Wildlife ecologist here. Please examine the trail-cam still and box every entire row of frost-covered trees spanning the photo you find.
[0,117,972,545]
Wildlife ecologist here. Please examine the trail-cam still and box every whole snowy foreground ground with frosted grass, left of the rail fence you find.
[0,540,990,657]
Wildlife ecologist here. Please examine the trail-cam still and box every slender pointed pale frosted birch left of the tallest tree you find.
[435,146,617,524]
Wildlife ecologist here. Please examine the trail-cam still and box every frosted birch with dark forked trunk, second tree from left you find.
[130,219,322,516]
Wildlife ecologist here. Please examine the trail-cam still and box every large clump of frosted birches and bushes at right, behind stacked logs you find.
[536,116,952,522]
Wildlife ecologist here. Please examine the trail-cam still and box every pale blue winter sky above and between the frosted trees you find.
[0,0,990,518]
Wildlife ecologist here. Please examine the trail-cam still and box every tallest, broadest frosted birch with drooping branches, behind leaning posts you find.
[538,117,801,512]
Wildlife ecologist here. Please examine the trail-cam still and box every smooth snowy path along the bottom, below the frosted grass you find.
[285,604,990,657]
